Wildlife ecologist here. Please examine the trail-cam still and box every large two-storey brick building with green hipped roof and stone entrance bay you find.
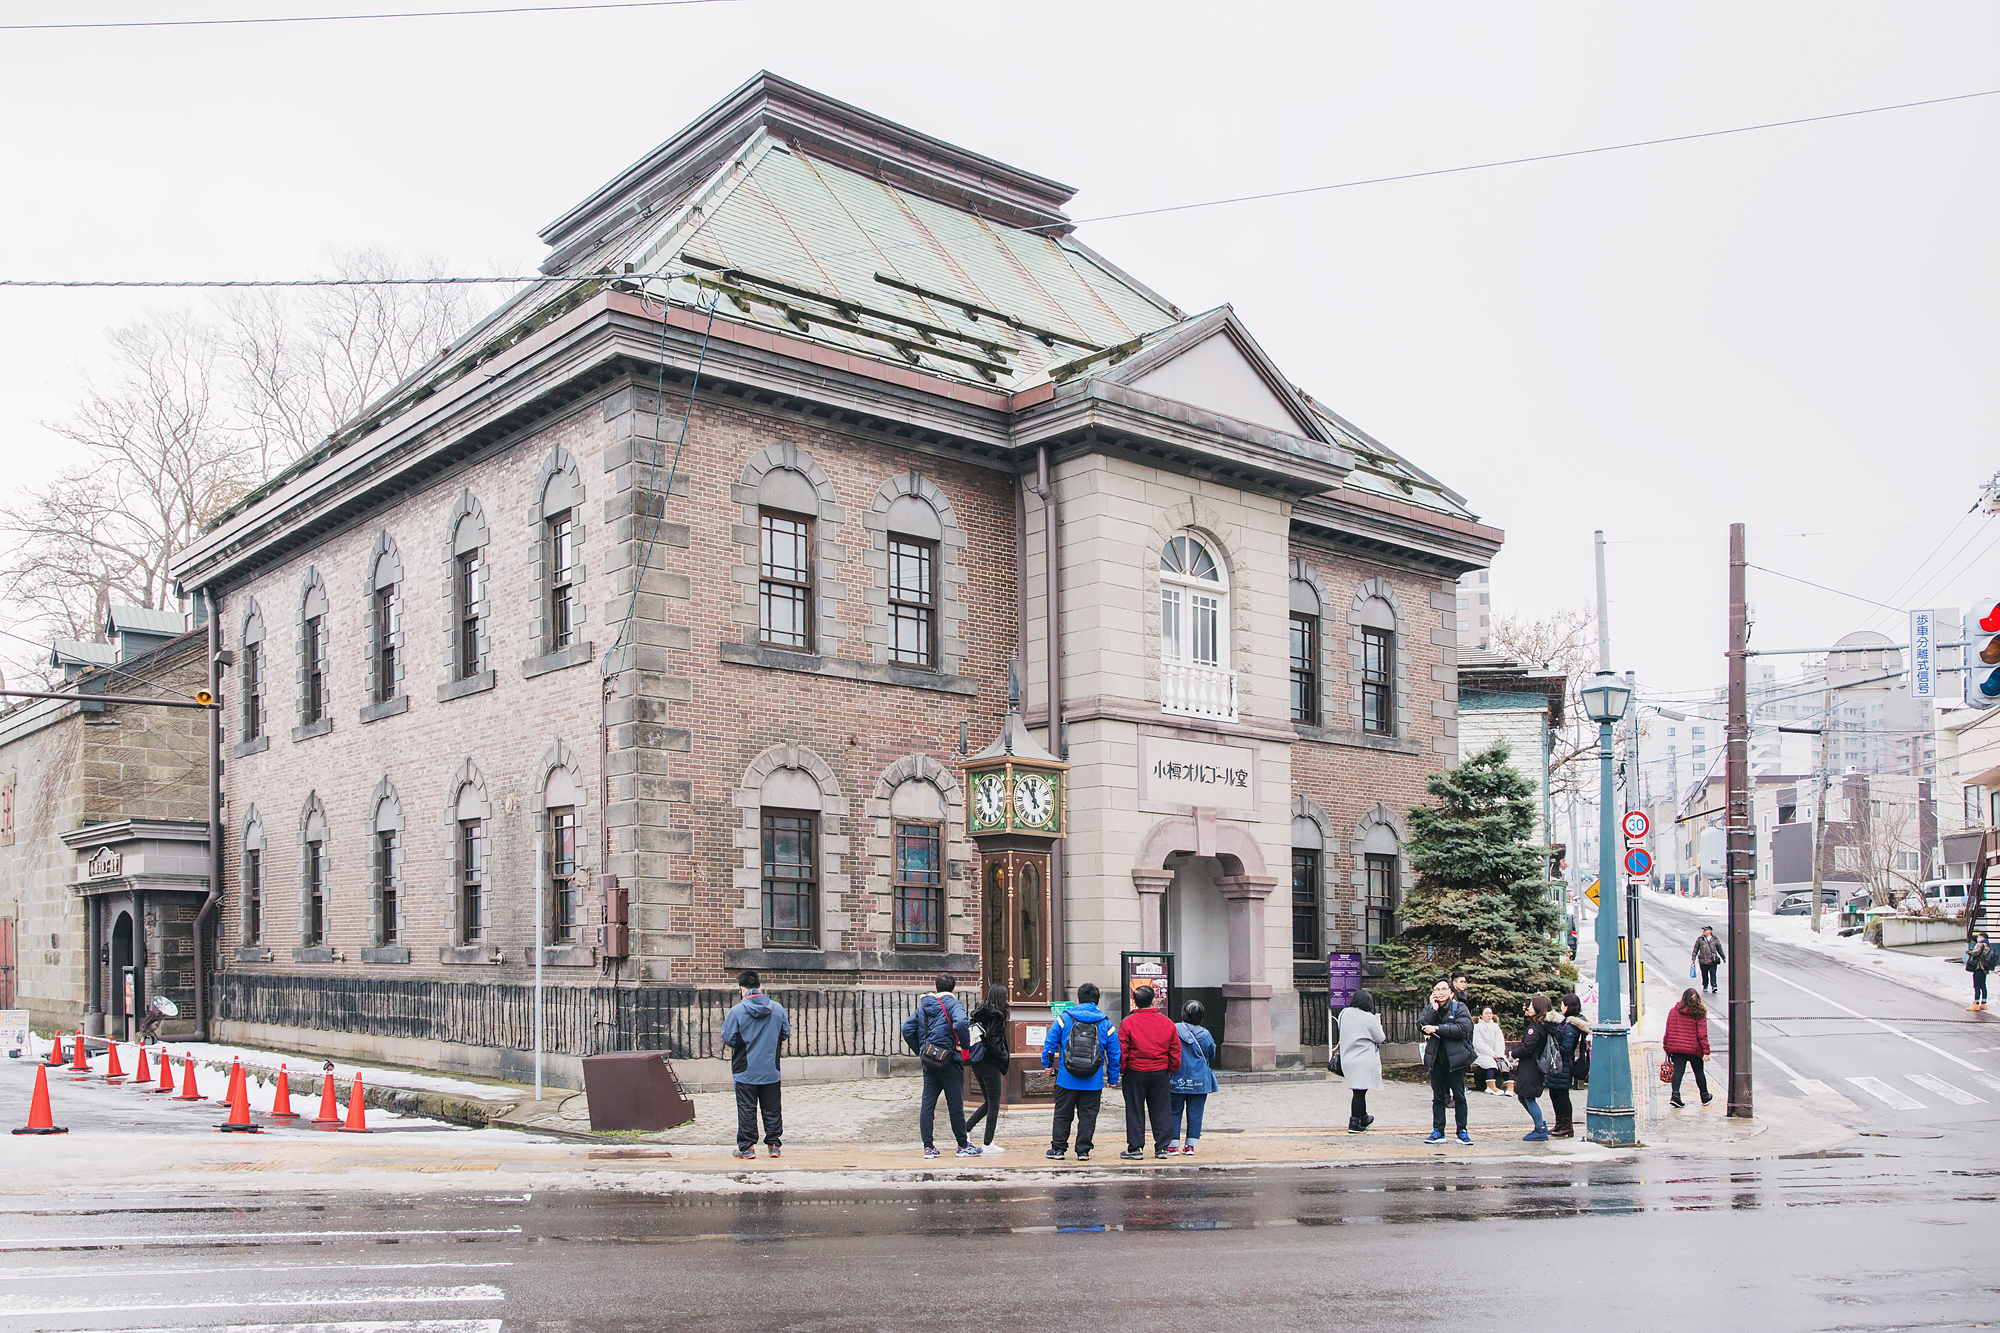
[164,74,1500,1075]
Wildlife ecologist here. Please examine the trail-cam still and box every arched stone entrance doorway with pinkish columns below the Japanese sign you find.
[1132,811,1278,1069]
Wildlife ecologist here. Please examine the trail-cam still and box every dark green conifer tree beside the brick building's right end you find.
[1374,741,1566,1016]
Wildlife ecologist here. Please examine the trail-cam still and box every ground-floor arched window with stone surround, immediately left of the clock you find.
[862,755,976,955]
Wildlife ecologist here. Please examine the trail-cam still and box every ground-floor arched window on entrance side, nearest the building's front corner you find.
[734,741,852,948]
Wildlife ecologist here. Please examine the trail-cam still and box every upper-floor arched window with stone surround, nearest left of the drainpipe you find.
[862,468,966,675]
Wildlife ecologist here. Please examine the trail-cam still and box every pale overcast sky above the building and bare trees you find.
[0,0,2000,691]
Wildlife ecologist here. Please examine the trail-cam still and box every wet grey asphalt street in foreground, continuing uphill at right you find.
[0,912,2000,1333]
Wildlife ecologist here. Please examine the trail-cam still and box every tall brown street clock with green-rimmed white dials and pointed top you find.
[964,671,1070,1097]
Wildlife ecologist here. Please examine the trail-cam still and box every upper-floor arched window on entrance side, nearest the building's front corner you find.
[730,444,848,656]
